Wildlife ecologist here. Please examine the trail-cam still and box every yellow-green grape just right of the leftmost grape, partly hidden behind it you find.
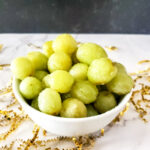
[27,51,48,70]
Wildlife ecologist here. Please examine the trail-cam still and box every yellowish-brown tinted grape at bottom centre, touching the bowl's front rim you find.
[60,98,87,118]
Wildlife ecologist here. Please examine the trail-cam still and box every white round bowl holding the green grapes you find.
[13,78,131,136]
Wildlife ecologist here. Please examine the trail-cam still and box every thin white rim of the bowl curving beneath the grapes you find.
[12,77,132,122]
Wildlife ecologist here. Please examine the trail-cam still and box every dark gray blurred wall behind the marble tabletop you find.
[0,0,150,34]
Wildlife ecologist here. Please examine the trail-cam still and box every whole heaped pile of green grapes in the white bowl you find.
[11,34,133,118]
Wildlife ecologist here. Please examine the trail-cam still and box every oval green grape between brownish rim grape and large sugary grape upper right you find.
[71,81,98,104]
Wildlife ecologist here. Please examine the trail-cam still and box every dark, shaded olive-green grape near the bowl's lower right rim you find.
[94,91,117,113]
